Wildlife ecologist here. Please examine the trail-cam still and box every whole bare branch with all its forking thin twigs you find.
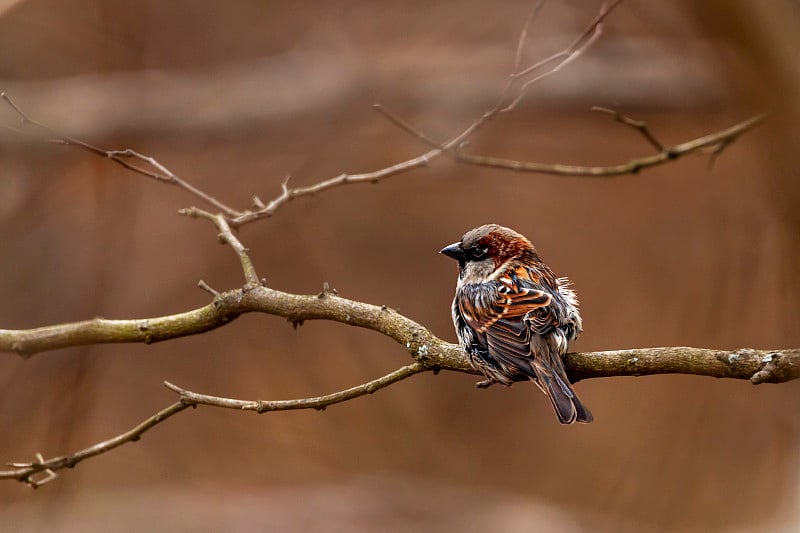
[0,0,788,488]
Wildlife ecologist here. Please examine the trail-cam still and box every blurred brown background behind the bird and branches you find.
[0,0,800,531]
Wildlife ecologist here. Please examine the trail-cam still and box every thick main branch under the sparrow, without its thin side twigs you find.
[0,286,800,383]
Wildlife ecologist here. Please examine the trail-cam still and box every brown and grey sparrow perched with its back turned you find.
[439,224,593,424]
